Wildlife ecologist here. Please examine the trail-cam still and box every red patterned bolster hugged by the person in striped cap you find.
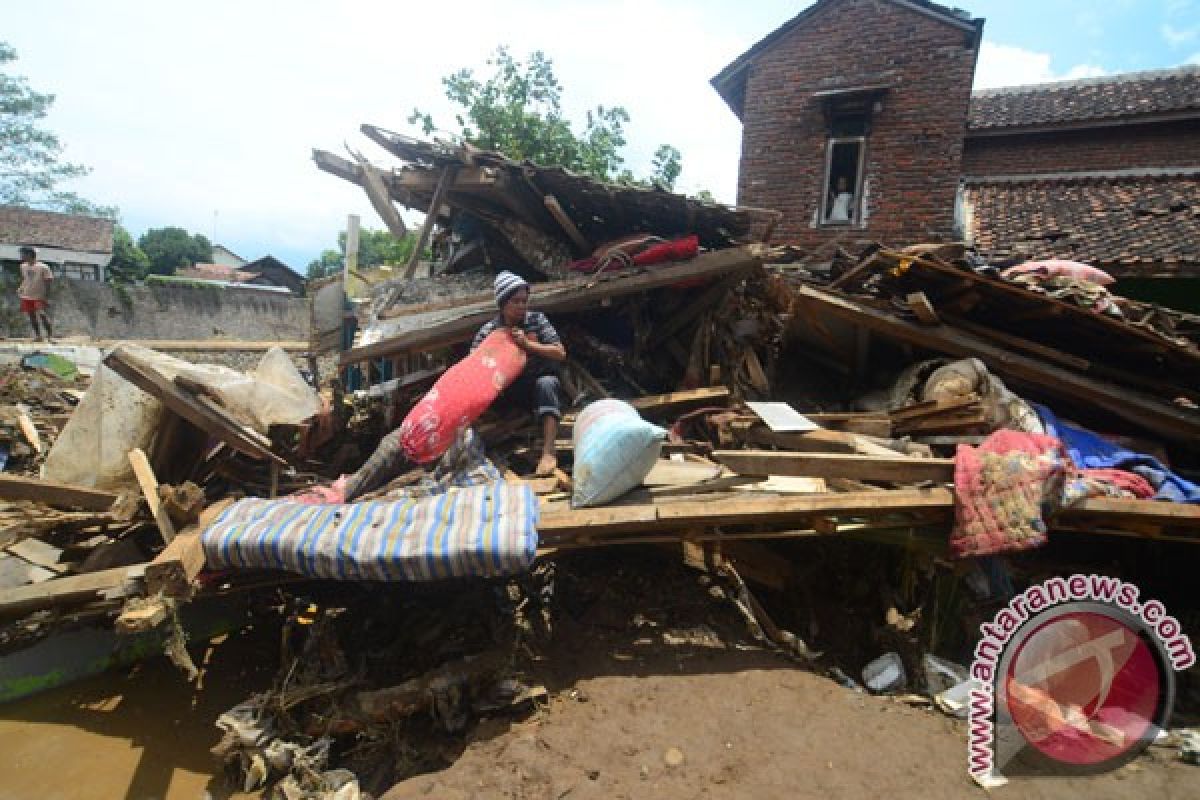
[400,327,526,464]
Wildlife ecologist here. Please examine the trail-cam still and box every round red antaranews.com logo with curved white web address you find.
[967,575,1195,786]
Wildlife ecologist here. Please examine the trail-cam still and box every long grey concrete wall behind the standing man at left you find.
[0,279,308,342]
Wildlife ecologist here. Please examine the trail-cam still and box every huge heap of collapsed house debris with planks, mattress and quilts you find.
[0,126,1200,799]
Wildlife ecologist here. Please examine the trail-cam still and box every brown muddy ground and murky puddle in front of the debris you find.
[0,551,1200,800]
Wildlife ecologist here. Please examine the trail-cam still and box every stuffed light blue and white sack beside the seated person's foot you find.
[571,398,667,507]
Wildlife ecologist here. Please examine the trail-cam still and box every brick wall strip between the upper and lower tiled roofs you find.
[962,120,1200,176]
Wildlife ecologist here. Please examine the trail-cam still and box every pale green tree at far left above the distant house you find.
[0,42,116,218]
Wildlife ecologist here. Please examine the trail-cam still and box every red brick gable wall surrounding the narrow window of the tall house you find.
[738,0,977,248]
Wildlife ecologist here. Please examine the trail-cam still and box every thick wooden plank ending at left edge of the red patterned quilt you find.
[713,450,954,483]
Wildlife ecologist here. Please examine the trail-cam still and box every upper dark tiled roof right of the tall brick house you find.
[967,66,1200,131]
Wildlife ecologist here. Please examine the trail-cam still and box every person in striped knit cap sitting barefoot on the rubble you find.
[470,272,566,475]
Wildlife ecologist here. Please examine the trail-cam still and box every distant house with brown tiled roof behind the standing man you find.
[0,205,114,281]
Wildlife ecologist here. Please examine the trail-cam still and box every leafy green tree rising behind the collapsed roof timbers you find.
[408,47,680,190]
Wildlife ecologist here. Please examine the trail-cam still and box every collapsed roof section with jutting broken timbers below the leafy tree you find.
[313,125,779,279]
